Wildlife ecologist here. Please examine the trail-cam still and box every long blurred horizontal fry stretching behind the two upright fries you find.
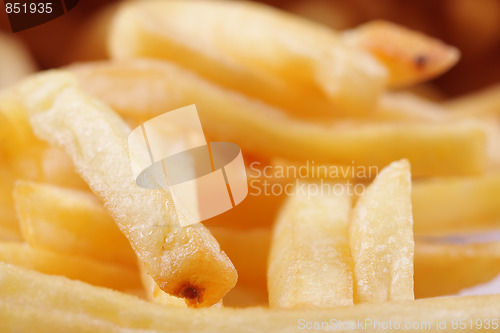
[70,60,486,176]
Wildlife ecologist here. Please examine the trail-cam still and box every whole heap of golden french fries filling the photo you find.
[0,0,500,332]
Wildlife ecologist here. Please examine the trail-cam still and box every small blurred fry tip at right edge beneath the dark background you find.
[444,84,500,117]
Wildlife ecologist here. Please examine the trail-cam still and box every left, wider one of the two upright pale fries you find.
[267,184,353,309]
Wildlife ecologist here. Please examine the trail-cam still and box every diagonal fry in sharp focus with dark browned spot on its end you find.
[19,72,237,306]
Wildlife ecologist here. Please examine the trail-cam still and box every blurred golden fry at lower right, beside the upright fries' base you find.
[415,242,500,298]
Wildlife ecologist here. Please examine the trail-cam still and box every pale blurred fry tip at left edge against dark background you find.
[0,32,36,89]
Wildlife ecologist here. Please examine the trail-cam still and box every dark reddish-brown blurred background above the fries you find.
[0,0,500,99]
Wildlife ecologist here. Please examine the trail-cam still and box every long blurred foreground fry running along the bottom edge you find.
[0,264,500,333]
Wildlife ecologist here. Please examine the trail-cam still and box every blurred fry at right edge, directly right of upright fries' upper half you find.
[412,172,500,234]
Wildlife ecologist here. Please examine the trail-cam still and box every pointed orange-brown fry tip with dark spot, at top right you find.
[343,21,460,87]
